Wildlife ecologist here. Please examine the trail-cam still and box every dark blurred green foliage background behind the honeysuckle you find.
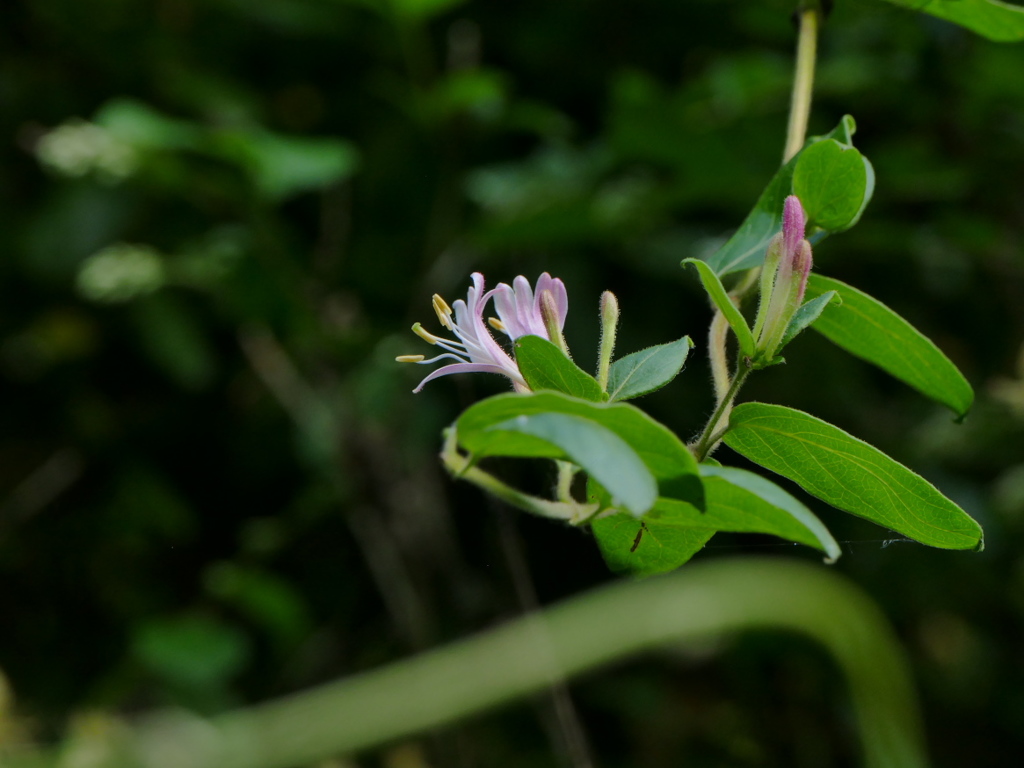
[0,0,1024,768]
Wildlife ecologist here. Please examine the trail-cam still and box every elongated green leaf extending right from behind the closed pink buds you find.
[806,274,974,417]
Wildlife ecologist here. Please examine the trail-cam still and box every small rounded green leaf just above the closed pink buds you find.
[793,138,874,232]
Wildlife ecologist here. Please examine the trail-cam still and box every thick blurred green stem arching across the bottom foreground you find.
[61,557,928,768]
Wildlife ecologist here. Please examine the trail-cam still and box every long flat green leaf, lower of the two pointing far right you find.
[725,402,982,549]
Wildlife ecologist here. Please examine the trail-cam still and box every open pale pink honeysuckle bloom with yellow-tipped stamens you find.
[395,272,568,392]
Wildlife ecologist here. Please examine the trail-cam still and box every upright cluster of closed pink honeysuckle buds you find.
[754,195,812,360]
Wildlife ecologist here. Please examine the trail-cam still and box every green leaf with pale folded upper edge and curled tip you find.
[700,464,842,562]
